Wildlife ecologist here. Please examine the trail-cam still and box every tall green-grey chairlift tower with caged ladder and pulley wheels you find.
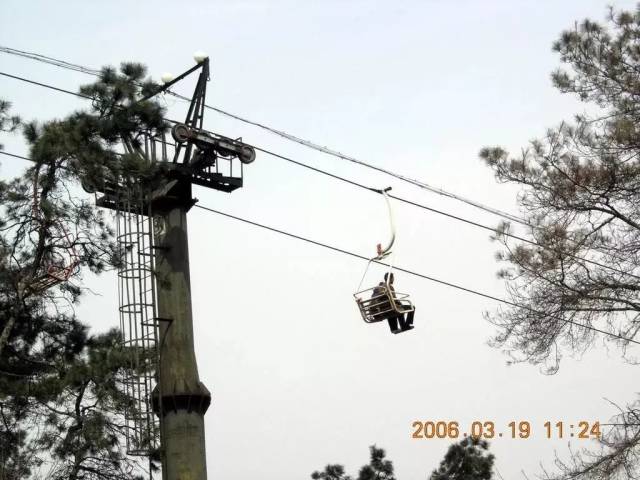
[92,58,255,480]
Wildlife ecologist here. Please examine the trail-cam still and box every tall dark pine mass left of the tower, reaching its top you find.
[0,63,167,480]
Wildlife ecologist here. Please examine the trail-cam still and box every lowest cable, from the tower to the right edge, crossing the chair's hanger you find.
[195,204,640,345]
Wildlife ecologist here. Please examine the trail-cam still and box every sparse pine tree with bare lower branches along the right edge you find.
[480,5,640,480]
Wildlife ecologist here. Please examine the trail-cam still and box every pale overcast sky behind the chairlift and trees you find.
[0,0,637,480]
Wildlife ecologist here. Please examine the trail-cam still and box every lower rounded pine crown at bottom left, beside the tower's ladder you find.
[29,330,154,480]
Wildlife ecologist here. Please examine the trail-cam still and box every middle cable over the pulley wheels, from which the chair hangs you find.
[0,65,640,279]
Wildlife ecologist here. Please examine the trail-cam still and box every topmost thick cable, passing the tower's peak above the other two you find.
[0,46,535,228]
